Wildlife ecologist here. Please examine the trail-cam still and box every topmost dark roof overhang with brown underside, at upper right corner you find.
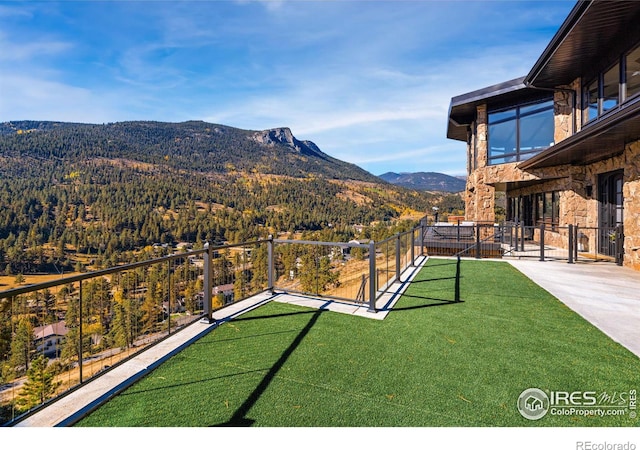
[524,0,640,88]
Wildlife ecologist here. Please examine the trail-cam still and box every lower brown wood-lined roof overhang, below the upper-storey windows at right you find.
[518,97,640,170]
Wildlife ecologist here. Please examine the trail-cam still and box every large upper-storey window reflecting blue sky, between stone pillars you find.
[489,99,554,164]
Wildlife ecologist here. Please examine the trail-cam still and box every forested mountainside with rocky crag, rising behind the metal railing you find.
[0,122,460,275]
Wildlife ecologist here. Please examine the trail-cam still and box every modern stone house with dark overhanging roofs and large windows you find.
[447,0,640,270]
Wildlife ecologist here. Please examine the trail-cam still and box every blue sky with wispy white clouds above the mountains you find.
[0,0,575,175]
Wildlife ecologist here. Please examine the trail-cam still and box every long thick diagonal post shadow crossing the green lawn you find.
[210,309,326,427]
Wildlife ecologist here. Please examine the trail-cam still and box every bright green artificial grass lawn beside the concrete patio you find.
[77,259,640,427]
